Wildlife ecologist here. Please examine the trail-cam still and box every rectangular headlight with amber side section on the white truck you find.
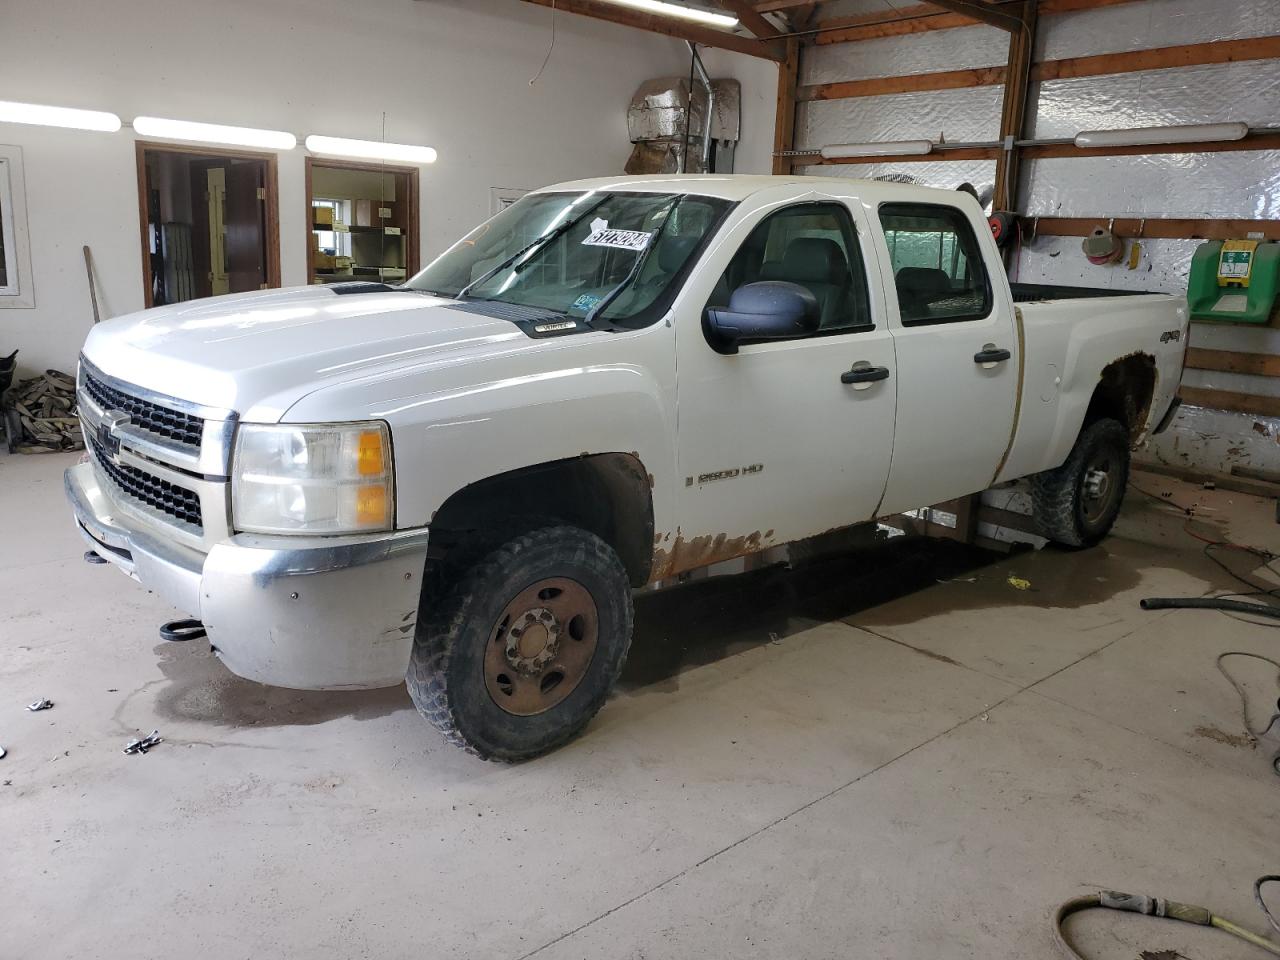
[232,421,396,534]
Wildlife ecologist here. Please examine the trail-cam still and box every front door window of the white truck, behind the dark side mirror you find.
[707,204,872,337]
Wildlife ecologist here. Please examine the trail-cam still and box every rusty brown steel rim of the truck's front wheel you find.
[484,577,600,717]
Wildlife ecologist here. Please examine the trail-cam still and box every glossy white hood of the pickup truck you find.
[84,287,529,421]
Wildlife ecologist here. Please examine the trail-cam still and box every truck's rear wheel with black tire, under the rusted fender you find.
[1030,420,1129,548]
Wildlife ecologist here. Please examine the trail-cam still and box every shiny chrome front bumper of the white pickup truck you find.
[64,463,428,690]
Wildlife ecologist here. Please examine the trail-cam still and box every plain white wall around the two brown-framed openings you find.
[0,0,777,370]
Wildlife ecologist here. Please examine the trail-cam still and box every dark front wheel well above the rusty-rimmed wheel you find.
[430,453,653,586]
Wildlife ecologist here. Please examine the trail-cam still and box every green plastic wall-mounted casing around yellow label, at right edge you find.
[1187,241,1280,324]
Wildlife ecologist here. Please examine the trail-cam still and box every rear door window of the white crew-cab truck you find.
[879,204,992,325]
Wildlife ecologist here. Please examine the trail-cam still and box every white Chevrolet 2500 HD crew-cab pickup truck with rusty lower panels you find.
[65,175,1188,759]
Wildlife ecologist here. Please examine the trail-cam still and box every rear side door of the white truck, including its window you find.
[877,202,1020,515]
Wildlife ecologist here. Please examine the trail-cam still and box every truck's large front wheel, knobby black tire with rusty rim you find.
[406,526,632,760]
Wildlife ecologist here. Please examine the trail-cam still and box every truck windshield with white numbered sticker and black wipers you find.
[406,191,732,326]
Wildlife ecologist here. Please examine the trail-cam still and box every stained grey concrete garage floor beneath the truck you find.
[0,456,1280,960]
